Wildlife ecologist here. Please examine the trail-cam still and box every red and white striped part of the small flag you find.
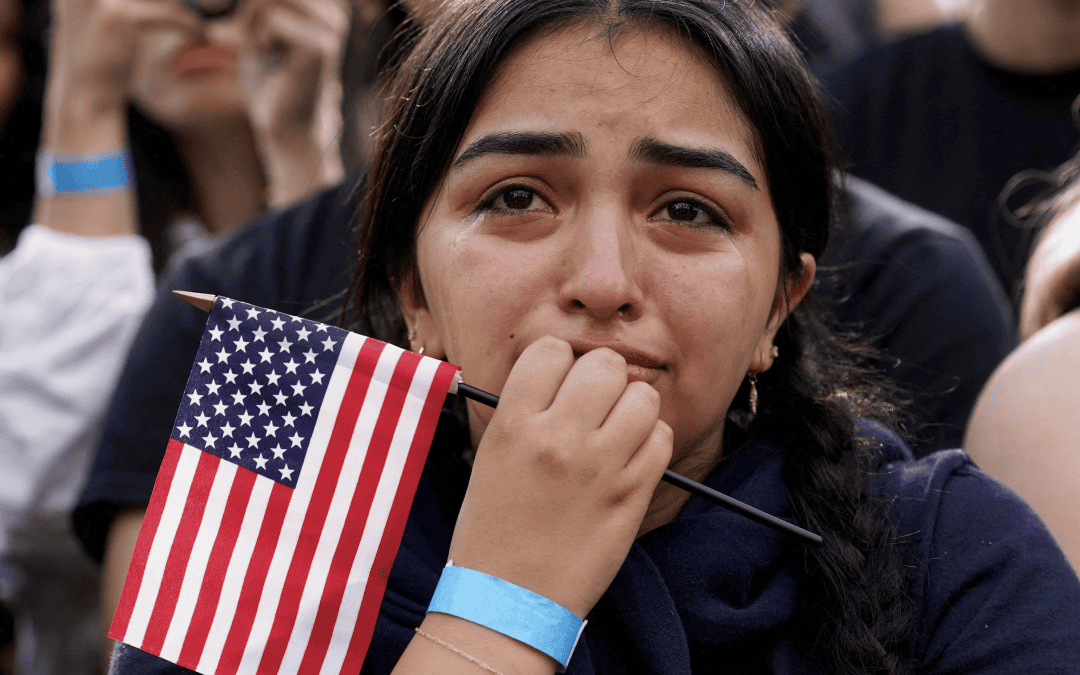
[109,335,456,675]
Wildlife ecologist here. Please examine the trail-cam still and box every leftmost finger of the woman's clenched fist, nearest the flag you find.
[499,336,573,413]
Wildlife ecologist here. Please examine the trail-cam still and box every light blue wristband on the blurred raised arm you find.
[37,150,134,197]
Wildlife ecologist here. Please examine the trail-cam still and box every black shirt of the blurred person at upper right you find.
[824,26,1080,294]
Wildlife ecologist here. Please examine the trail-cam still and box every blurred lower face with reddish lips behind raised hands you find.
[132,0,246,131]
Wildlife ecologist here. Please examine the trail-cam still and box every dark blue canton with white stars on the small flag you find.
[173,297,348,487]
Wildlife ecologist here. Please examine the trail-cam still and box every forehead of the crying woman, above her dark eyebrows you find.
[458,22,766,181]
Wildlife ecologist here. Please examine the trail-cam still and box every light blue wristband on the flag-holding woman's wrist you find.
[428,563,588,669]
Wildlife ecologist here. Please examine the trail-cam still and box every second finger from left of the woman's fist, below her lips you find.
[551,348,626,430]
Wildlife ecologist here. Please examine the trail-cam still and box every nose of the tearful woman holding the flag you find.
[559,217,644,321]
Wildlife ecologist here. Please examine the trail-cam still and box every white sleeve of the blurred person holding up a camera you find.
[0,225,154,552]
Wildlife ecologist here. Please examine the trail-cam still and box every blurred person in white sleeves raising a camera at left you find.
[0,0,351,673]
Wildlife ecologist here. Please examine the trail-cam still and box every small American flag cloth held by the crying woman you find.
[109,297,457,675]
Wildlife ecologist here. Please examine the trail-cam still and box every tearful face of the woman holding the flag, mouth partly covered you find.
[401,21,813,474]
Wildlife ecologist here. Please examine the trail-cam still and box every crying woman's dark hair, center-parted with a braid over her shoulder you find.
[346,0,913,674]
